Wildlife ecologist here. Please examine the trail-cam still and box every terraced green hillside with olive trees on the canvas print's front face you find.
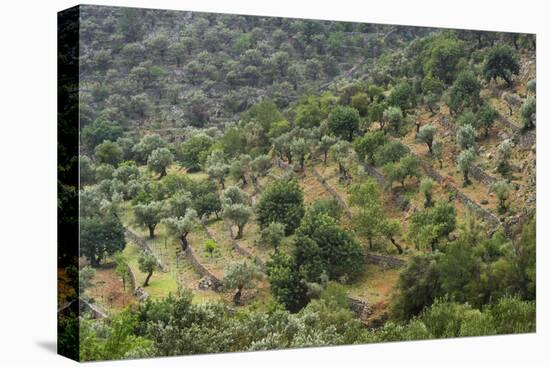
[69,7,536,359]
